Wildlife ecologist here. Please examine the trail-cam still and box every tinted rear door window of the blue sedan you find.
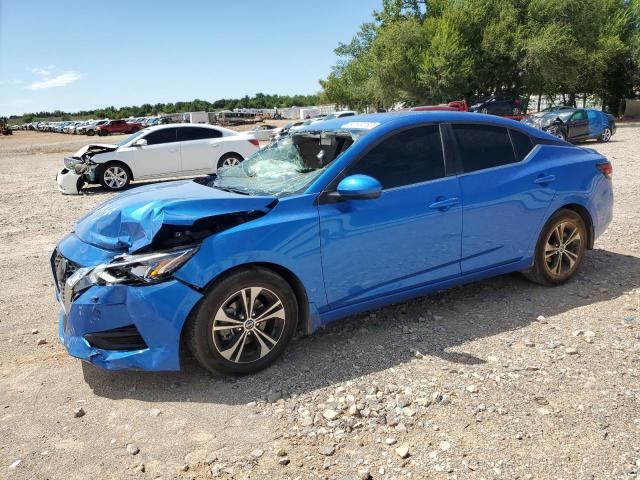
[452,124,516,173]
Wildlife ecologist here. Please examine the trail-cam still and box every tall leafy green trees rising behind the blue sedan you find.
[320,0,640,113]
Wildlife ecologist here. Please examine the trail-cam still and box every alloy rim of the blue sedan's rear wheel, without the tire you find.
[544,222,582,277]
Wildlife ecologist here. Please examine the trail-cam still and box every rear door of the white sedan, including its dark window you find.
[178,126,223,173]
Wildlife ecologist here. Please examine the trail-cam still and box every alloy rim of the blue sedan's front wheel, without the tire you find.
[211,287,286,363]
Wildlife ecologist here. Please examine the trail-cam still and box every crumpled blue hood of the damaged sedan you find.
[75,180,276,252]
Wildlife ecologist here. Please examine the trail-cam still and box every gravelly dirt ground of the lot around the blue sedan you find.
[0,124,640,480]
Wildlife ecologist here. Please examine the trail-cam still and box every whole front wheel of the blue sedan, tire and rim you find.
[186,267,298,375]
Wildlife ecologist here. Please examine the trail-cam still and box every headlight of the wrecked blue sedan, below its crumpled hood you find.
[89,247,198,285]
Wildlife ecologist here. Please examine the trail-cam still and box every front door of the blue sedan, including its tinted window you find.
[318,125,462,308]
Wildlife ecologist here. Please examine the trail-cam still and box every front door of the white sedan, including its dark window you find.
[126,127,180,178]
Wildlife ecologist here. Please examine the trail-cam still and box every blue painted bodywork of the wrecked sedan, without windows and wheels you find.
[53,112,613,370]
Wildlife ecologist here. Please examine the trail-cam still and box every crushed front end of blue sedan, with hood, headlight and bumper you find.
[51,180,277,371]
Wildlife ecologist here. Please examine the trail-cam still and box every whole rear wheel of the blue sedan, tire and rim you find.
[524,209,587,286]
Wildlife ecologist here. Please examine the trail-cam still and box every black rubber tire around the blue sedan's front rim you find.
[188,267,298,375]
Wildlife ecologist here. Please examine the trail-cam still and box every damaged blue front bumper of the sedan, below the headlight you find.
[52,236,202,371]
